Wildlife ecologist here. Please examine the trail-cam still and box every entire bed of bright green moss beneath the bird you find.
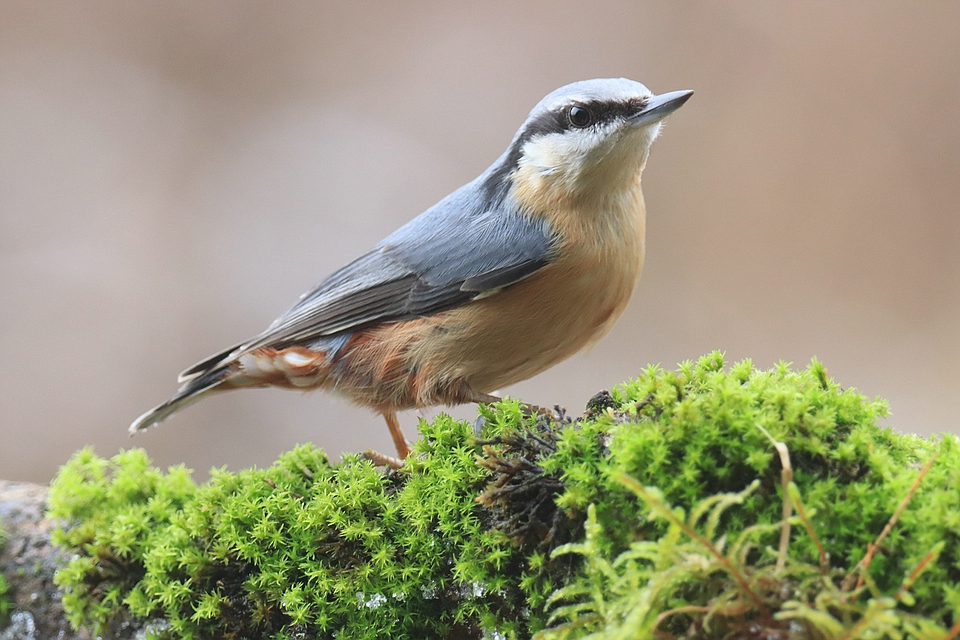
[51,354,960,638]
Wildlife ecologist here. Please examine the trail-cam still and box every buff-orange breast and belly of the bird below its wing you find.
[409,189,644,393]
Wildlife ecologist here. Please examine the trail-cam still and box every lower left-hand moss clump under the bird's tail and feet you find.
[51,417,540,638]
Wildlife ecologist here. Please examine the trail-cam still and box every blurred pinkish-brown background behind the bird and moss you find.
[0,0,960,481]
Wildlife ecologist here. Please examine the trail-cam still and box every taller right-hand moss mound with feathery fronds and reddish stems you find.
[540,354,960,639]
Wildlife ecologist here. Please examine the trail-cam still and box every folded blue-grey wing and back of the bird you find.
[181,176,554,380]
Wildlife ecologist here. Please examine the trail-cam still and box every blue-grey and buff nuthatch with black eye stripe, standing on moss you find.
[129,78,693,461]
